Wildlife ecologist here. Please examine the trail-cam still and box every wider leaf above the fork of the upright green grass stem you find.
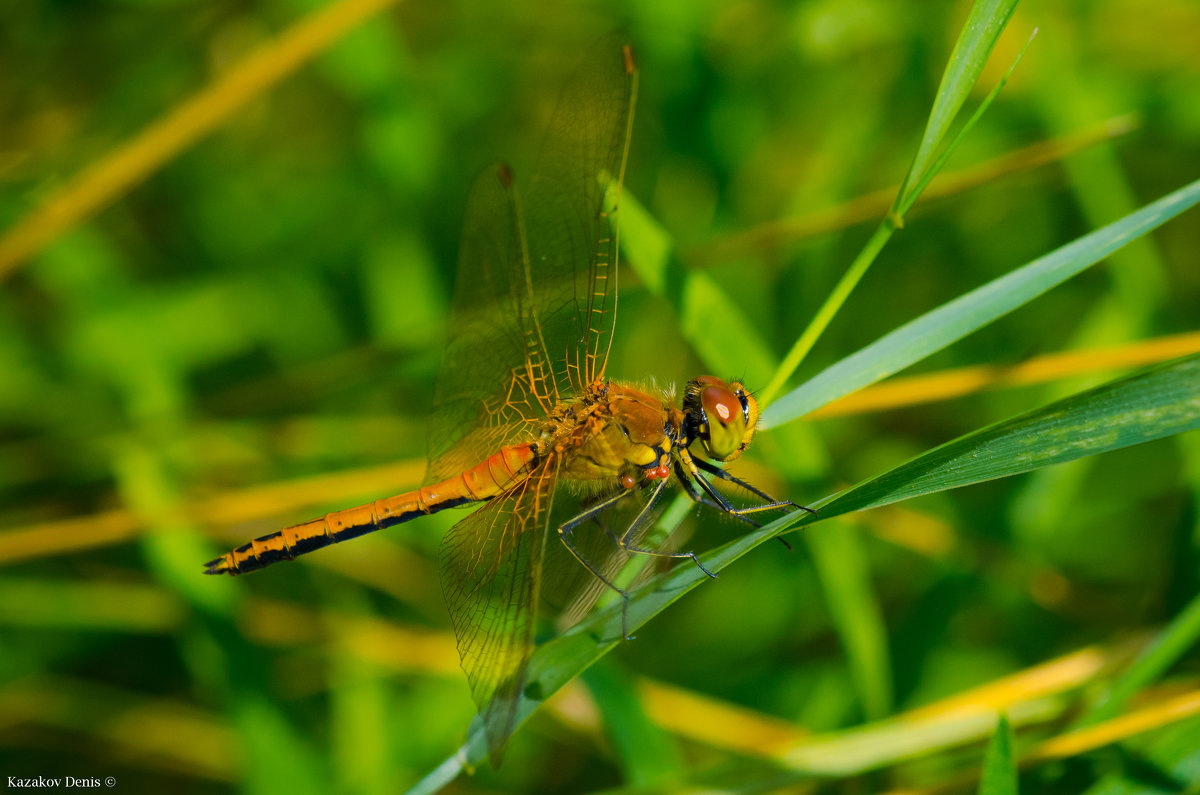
[898,0,1016,197]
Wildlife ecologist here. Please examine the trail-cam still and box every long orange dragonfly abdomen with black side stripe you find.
[204,444,536,574]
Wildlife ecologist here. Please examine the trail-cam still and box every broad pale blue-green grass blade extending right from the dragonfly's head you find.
[760,180,1200,428]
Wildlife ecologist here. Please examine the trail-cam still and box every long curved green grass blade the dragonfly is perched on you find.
[412,354,1200,793]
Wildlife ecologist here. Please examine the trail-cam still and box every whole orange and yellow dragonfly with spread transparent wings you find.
[205,41,810,766]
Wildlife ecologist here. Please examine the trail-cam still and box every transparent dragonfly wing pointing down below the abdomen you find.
[439,460,556,766]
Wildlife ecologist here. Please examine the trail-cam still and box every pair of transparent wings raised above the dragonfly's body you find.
[428,37,636,482]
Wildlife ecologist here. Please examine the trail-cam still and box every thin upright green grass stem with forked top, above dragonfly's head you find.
[760,0,1028,406]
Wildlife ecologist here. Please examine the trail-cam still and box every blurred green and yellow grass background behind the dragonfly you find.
[0,0,1200,794]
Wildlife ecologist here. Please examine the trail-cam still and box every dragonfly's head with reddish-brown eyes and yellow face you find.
[683,376,758,461]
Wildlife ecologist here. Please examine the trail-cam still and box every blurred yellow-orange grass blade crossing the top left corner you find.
[0,0,398,280]
